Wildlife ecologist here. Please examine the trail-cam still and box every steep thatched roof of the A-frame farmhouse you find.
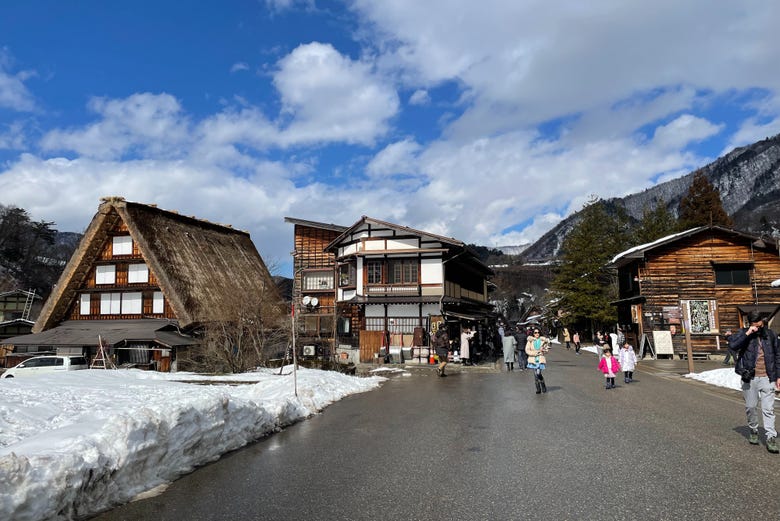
[33,197,280,333]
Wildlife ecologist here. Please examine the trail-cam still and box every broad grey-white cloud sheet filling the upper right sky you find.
[355,0,780,134]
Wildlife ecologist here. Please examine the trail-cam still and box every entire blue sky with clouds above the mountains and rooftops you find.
[0,0,780,274]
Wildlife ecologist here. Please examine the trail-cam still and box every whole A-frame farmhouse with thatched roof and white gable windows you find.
[3,197,280,371]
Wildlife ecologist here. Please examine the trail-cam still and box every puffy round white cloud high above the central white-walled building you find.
[274,43,399,145]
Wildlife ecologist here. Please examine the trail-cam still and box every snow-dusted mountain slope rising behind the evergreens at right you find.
[523,130,780,262]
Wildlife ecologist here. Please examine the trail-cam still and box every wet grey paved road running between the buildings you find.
[97,348,780,521]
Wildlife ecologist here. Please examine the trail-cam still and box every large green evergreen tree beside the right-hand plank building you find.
[551,198,631,326]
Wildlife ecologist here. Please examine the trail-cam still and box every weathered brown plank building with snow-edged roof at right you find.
[612,226,780,356]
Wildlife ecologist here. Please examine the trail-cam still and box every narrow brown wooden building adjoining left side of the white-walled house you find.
[284,217,347,356]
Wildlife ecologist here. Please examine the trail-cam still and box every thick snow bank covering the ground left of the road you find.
[0,367,385,521]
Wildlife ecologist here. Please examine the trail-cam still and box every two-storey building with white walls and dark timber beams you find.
[325,216,493,362]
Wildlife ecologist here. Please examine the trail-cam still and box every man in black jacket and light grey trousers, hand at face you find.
[729,311,780,454]
